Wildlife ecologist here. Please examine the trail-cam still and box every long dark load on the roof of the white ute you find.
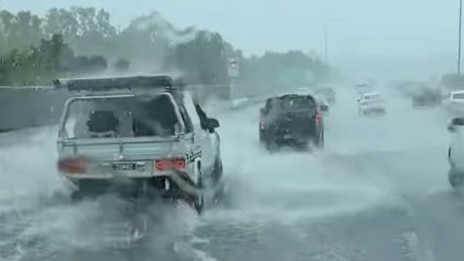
[53,75,185,92]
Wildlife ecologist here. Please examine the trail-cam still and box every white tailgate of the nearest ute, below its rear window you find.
[58,139,193,179]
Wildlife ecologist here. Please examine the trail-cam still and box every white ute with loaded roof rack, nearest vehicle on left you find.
[54,76,222,213]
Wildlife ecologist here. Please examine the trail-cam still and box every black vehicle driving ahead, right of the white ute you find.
[259,94,324,150]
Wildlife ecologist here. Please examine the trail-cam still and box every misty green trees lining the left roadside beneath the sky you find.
[0,7,331,89]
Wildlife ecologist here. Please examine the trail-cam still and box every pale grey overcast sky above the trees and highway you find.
[0,0,459,77]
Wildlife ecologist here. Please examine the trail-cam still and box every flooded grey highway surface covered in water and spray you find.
[0,86,464,261]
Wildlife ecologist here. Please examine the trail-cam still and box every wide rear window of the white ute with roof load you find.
[64,95,182,138]
